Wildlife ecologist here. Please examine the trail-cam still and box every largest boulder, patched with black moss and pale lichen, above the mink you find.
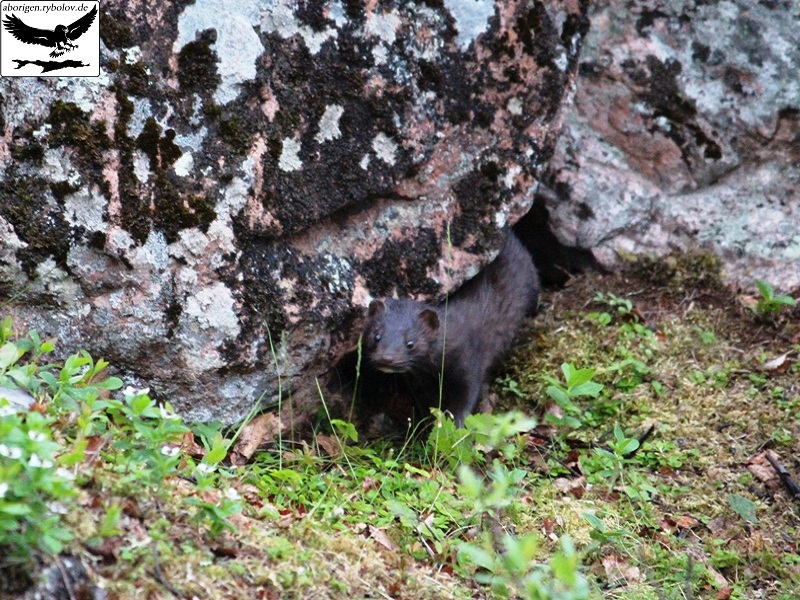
[0,0,588,422]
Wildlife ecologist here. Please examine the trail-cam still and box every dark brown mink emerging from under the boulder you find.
[362,233,539,427]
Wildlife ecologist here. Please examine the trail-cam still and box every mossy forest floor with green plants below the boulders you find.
[0,254,800,600]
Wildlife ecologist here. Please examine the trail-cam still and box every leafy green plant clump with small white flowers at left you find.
[0,318,248,565]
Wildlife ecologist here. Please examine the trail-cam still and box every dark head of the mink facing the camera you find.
[363,299,439,373]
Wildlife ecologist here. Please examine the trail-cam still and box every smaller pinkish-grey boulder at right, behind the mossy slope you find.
[546,0,800,290]
